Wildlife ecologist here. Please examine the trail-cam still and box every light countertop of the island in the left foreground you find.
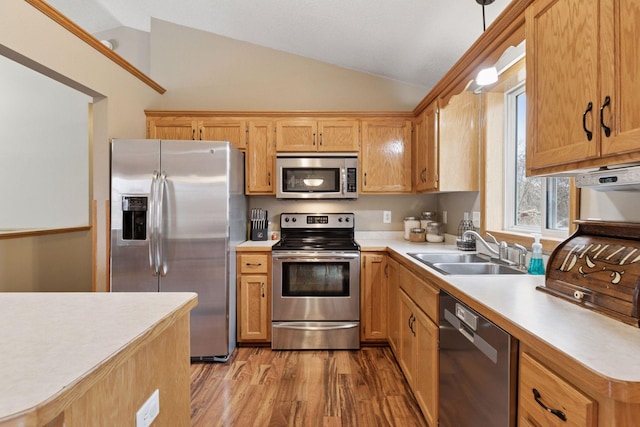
[0,292,197,421]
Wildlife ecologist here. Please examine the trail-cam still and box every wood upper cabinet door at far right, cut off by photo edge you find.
[597,0,640,156]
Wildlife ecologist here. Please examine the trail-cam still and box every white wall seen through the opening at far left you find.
[0,56,92,231]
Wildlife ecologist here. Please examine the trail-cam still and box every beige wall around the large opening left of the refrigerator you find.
[0,0,160,291]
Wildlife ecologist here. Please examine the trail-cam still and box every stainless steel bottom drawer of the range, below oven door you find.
[271,322,360,350]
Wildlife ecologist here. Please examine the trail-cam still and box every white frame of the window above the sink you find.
[503,81,569,238]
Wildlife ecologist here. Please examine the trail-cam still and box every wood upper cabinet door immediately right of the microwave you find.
[360,119,411,194]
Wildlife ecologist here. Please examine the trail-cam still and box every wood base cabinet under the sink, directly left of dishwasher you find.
[396,266,439,426]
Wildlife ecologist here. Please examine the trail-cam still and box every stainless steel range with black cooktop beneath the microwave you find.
[271,213,360,350]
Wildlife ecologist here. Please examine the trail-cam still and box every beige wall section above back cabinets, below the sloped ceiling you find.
[151,19,427,111]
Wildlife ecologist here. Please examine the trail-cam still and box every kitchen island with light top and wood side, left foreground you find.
[0,293,197,427]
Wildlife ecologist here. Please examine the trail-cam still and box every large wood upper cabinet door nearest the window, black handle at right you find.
[526,0,600,171]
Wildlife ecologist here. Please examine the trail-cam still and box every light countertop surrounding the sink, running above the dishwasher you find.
[356,234,640,390]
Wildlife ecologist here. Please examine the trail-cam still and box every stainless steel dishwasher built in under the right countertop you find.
[439,291,518,427]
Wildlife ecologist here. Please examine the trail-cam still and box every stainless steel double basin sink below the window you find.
[409,253,526,275]
